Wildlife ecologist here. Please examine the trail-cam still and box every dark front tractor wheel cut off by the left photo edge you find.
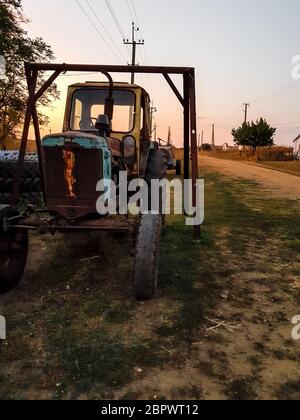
[0,205,28,293]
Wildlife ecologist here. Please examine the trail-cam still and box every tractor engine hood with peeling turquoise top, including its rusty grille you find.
[42,131,112,220]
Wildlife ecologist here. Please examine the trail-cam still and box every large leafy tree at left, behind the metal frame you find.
[0,0,59,149]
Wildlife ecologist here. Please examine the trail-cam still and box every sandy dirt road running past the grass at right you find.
[200,156,300,200]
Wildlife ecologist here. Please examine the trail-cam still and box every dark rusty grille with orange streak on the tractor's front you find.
[44,147,103,219]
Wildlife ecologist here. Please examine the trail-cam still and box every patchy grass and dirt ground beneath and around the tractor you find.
[0,166,300,399]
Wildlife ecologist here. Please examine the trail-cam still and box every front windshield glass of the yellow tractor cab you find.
[70,89,135,133]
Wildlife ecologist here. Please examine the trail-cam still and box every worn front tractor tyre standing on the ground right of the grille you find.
[134,214,162,300]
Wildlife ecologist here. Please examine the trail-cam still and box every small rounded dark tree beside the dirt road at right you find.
[232,118,276,155]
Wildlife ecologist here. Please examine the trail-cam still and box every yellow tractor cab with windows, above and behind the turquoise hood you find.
[63,82,151,167]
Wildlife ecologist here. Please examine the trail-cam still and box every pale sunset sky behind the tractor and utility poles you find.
[23,0,300,146]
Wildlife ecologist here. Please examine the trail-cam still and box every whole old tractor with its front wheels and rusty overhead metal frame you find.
[0,64,200,299]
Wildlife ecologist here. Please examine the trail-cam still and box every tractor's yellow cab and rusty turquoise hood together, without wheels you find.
[42,82,154,220]
